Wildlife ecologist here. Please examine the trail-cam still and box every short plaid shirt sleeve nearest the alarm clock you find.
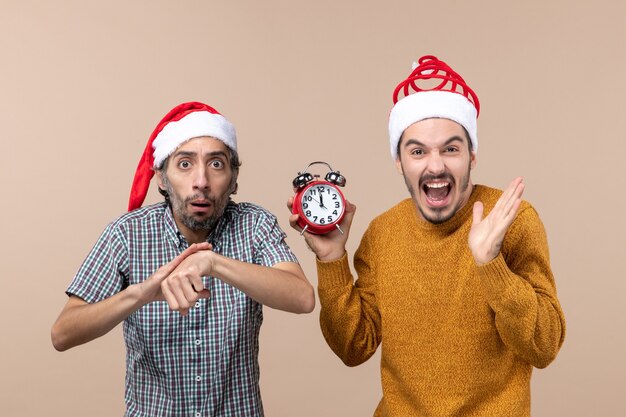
[254,213,298,267]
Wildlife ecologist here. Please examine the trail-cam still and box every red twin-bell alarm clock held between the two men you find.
[291,161,346,235]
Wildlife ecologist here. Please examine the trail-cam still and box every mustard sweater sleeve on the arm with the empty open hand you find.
[477,205,565,368]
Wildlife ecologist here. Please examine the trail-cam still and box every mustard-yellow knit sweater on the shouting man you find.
[317,186,565,417]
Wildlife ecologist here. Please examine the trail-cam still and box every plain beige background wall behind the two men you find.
[0,0,626,417]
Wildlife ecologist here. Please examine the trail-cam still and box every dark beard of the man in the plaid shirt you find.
[162,175,232,232]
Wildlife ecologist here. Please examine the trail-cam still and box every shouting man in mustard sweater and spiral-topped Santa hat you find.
[290,56,565,417]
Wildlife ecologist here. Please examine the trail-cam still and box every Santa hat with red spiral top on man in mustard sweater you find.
[389,55,480,160]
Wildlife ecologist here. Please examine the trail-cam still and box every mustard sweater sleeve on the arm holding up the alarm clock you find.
[317,226,381,366]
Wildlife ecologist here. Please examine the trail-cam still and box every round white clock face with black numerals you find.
[300,183,345,226]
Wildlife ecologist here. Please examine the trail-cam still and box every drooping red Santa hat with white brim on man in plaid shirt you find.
[128,101,237,211]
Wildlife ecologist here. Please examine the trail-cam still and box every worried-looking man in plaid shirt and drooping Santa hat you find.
[52,102,315,417]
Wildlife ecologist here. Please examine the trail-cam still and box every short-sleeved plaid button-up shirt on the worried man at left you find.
[67,202,297,417]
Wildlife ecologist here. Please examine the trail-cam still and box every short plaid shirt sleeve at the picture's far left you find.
[66,224,128,304]
